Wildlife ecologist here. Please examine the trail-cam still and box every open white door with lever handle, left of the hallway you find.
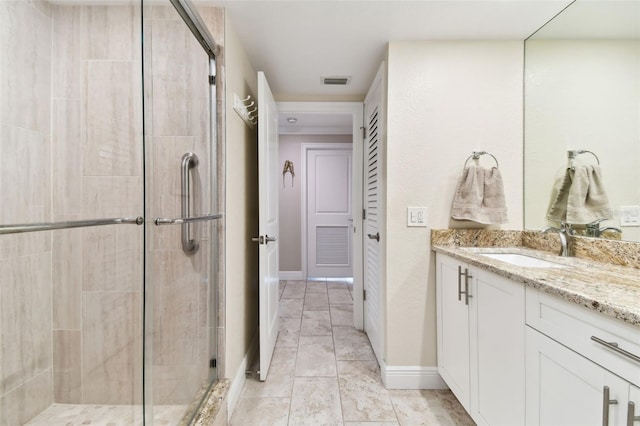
[258,72,280,381]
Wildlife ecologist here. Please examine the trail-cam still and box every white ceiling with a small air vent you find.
[199,0,571,133]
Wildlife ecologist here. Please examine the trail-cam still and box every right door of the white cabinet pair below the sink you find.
[469,268,525,426]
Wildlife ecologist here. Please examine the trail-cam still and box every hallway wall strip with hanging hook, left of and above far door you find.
[278,135,352,272]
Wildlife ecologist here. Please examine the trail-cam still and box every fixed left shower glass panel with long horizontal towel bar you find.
[0,0,144,426]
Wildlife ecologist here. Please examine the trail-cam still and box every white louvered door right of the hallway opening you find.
[363,67,384,363]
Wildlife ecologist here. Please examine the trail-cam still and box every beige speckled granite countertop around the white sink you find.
[432,245,640,328]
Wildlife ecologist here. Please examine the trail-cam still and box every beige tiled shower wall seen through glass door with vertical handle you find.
[145,6,219,404]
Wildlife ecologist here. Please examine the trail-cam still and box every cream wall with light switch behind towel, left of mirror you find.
[384,41,523,366]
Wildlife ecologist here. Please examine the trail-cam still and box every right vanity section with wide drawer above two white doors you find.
[526,288,640,426]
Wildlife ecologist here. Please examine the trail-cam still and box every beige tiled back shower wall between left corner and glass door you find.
[51,5,143,404]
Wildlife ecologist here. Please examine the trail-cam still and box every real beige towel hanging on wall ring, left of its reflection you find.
[451,166,508,225]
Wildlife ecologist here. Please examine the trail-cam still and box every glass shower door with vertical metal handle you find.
[144,0,219,424]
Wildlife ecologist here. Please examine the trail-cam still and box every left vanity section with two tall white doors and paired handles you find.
[436,253,525,425]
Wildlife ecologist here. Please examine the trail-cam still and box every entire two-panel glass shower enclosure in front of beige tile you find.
[0,0,217,426]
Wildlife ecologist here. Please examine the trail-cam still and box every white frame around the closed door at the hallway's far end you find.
[300,142,357,277]
